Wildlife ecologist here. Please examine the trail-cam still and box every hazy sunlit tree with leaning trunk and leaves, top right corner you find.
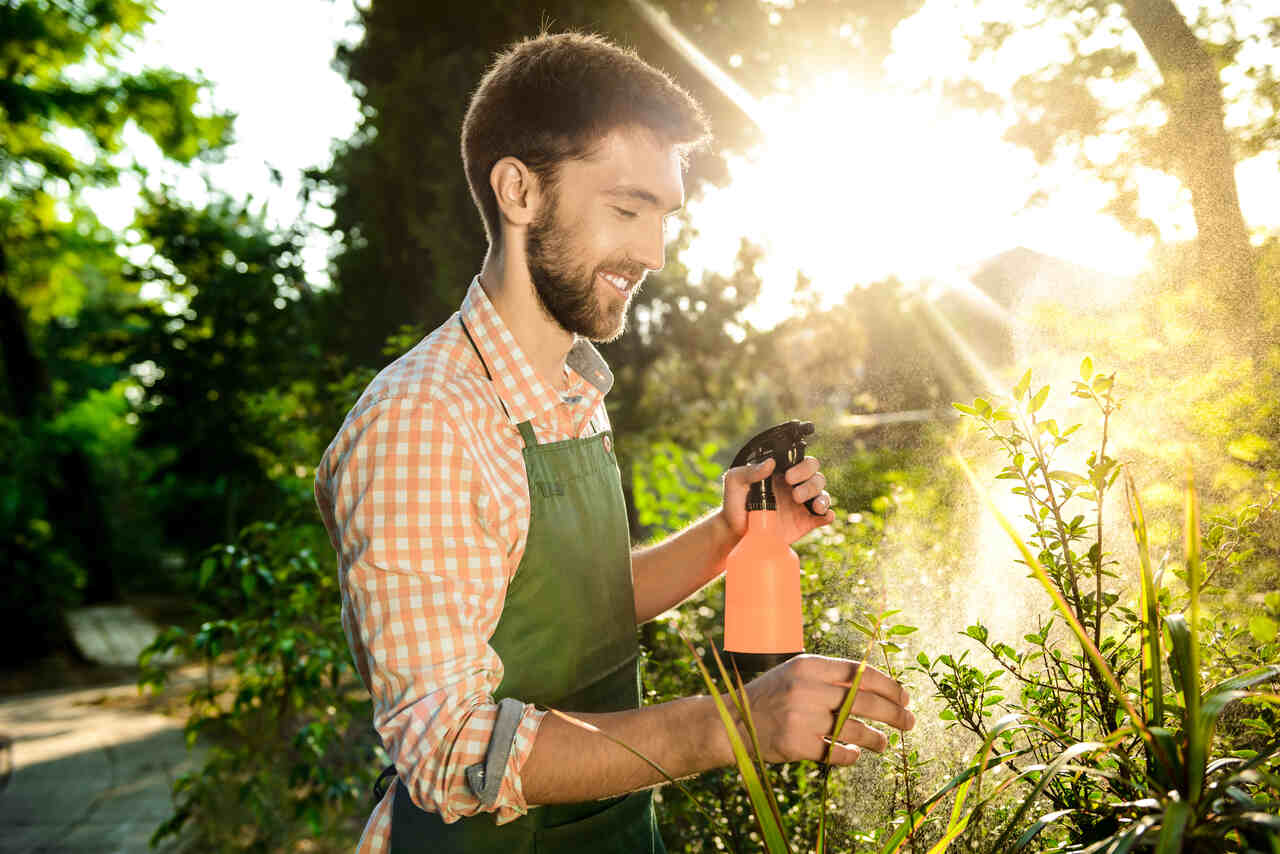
[951,0,1280,318]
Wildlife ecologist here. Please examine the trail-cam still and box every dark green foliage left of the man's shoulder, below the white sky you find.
[123,193,324,551]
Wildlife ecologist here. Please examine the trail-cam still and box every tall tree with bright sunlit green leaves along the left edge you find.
[0,0,229,647]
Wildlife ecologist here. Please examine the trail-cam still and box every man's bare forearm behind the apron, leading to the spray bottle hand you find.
[631,511,737,625]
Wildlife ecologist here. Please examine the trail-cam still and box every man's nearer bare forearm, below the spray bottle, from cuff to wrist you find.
[521,695,732,807]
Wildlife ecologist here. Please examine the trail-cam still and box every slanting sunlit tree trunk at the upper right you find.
[1123,0,1261,320]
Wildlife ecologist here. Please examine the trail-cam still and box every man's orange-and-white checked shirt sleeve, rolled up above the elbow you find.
[316,398,545,825]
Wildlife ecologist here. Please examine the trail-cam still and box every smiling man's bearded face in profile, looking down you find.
[525,131,685,341]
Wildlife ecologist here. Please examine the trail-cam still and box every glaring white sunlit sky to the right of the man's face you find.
[682,0,1280,326]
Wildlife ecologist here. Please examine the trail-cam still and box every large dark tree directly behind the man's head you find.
[311,0,920,364]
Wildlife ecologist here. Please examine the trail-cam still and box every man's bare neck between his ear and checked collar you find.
[480,234,573,388]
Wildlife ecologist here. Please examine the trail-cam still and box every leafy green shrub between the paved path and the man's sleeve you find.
[141,522,379,851]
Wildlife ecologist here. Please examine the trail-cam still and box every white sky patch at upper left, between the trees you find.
[87,0,361,283]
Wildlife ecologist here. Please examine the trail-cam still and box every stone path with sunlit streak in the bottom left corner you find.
[0,606,200,854]
